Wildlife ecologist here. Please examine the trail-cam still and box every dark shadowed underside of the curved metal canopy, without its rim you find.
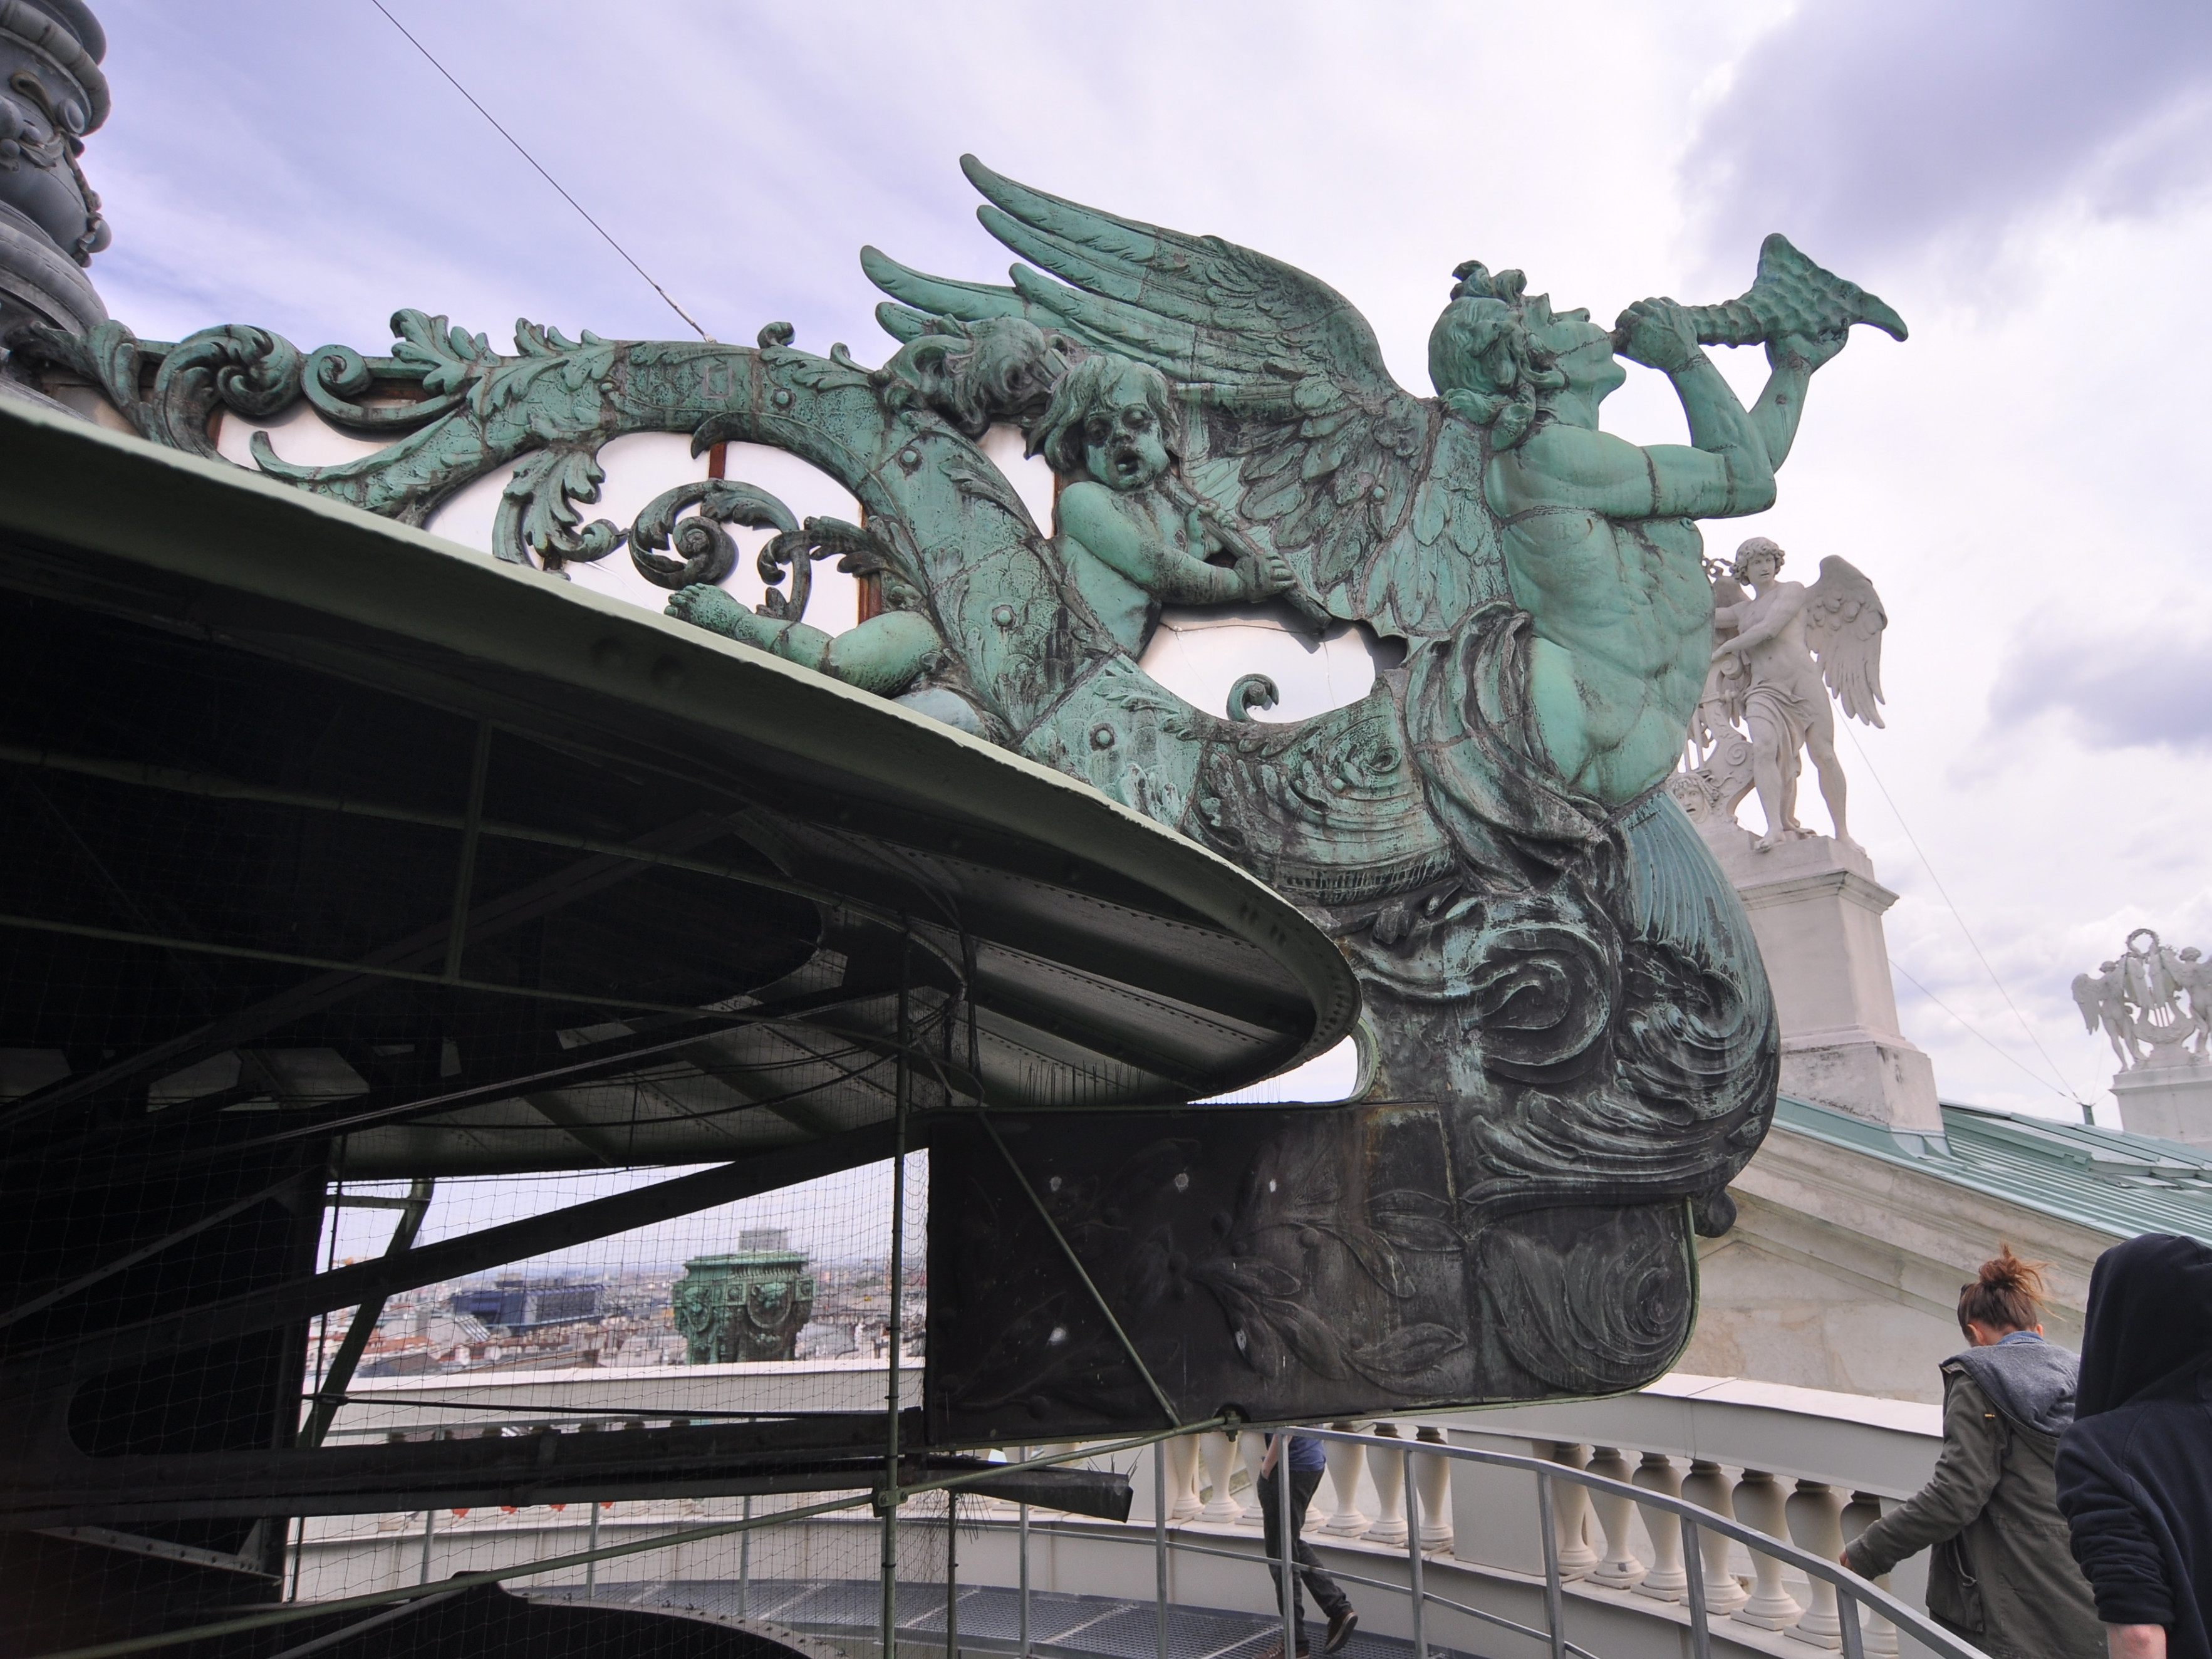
[0,595,1314,1179]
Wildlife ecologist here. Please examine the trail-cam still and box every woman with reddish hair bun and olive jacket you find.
[1842,1246,2106,1659]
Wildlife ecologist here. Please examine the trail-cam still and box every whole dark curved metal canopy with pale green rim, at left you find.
[0,403,1358,1177]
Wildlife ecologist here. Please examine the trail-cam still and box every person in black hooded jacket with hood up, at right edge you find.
[2057,1232,2212,1659]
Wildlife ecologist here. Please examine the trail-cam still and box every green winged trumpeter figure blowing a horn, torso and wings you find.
[863,157,1904,808]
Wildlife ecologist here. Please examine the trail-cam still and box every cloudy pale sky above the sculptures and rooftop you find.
[86,0,2212,1121]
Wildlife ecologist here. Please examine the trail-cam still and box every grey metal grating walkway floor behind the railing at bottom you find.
[531,1579,1480,1659]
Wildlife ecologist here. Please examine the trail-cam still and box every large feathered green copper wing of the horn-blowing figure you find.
[861,155,1504,635]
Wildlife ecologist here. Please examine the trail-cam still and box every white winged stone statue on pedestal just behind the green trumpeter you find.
[1675,535,1889,851]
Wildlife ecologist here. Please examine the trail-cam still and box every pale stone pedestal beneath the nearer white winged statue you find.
[1699,821,1942,1133]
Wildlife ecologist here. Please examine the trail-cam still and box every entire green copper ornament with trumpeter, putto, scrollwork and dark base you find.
[18,159,1904,1440]
